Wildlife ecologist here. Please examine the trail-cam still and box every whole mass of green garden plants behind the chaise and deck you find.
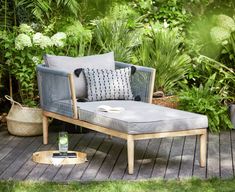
[0,0,235,132]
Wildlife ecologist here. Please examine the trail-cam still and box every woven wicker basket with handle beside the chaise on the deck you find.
[6,97,42,136]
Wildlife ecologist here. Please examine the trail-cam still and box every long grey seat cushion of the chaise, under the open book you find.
[78,100,208,134]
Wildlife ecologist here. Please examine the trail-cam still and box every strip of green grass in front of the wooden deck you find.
[0,178,235,192]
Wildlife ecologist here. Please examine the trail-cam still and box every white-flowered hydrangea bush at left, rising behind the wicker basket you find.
[0,24,67,106]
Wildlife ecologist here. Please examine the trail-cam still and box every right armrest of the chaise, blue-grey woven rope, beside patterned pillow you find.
[115,61,155,103]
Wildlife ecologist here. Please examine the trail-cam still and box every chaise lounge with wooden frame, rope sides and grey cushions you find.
[37,53,208,174]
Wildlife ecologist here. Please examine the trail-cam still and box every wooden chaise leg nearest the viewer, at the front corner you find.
[127,136,134,174]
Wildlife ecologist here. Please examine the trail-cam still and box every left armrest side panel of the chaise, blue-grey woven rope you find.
[36,65,74,117]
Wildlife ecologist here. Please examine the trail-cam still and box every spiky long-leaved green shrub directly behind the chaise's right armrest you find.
[136,29,191,93]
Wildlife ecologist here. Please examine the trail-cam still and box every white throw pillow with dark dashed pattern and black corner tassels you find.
[83,68,134,101]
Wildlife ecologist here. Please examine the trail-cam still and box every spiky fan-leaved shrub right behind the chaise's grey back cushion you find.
[92,6,142,62]
